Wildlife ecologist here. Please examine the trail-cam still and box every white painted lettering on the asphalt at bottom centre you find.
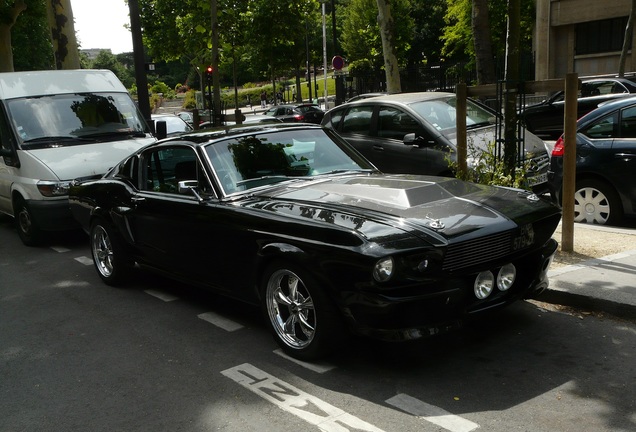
[221,363,383,432]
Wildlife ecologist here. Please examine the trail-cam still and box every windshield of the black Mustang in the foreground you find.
[206,129,374,194]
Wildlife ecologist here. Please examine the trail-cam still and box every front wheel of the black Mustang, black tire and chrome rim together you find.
[262,264,343,360]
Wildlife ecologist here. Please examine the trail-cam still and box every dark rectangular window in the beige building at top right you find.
[576,17,628,55]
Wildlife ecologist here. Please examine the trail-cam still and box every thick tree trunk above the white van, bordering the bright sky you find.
[47,0,80,69]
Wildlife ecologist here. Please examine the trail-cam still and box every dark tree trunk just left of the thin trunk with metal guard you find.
[471,0,496,84]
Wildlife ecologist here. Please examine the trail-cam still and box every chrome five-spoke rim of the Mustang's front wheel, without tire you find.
[265,269,317,349]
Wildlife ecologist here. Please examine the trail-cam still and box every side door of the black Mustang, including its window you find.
[127,146,226,280]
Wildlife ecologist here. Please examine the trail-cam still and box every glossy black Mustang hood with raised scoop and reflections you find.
[246,175,560,244]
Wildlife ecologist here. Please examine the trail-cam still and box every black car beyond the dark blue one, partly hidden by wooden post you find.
[521,78,636,140]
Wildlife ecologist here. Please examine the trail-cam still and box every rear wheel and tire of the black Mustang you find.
[90,219,133,286]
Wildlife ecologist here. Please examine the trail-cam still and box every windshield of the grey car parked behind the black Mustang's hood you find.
[410,96,495,132]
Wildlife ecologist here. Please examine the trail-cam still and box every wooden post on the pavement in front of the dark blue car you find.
[561,73,579,252]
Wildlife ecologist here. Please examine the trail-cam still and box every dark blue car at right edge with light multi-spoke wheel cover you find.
[549,97,636,225]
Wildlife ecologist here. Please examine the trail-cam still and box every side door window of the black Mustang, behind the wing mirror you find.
[142,147,212,194]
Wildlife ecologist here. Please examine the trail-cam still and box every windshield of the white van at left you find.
[7,93,149,148]
